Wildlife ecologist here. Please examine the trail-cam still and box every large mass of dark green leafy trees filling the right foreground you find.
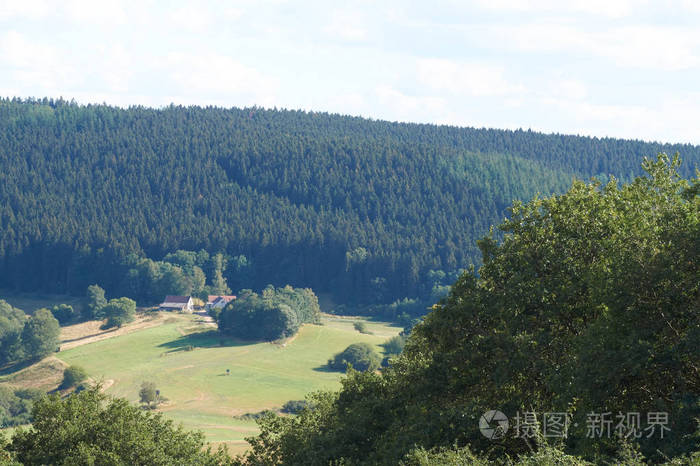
[242,155,700,465]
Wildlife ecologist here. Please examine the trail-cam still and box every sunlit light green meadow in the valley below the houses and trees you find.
[56,314,400,451]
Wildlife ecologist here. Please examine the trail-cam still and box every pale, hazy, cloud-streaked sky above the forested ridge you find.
[0,0,700,144]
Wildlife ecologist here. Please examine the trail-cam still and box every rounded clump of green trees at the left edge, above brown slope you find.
[0,299,61,365]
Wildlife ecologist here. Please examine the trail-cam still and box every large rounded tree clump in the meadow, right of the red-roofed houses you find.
[217,285,320,341]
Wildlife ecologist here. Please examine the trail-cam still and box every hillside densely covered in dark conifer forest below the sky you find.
[0,99,700,302]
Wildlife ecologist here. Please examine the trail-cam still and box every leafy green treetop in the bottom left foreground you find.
[6,387,230,466]
